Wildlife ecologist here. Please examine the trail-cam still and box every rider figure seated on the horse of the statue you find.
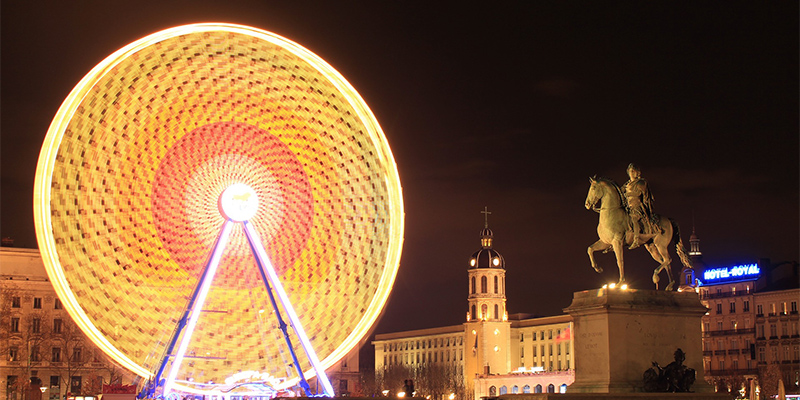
[622,164,660,249]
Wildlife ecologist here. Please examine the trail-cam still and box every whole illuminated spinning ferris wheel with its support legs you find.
[34,24,403,396]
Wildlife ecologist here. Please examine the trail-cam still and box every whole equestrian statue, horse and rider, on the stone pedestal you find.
[585,164,692,290]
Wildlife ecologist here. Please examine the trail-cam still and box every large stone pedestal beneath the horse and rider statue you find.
[564,289,713,393]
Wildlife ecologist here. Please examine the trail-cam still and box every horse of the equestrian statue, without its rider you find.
[585,178,691,290]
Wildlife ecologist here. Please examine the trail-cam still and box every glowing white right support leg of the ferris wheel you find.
[244,221,334,397]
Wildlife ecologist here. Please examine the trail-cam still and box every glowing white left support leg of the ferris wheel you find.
[159,220,234,398]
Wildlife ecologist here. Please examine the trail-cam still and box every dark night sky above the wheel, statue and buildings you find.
[0,0,800,333]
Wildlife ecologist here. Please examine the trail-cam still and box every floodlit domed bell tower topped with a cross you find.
[464,208,511,382]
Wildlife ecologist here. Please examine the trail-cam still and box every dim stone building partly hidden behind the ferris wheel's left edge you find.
[0,247,134,400]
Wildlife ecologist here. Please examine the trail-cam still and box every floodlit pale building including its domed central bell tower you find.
[373,222,575,399]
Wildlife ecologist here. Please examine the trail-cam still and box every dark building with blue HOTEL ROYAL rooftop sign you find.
[691,233,800,397]
